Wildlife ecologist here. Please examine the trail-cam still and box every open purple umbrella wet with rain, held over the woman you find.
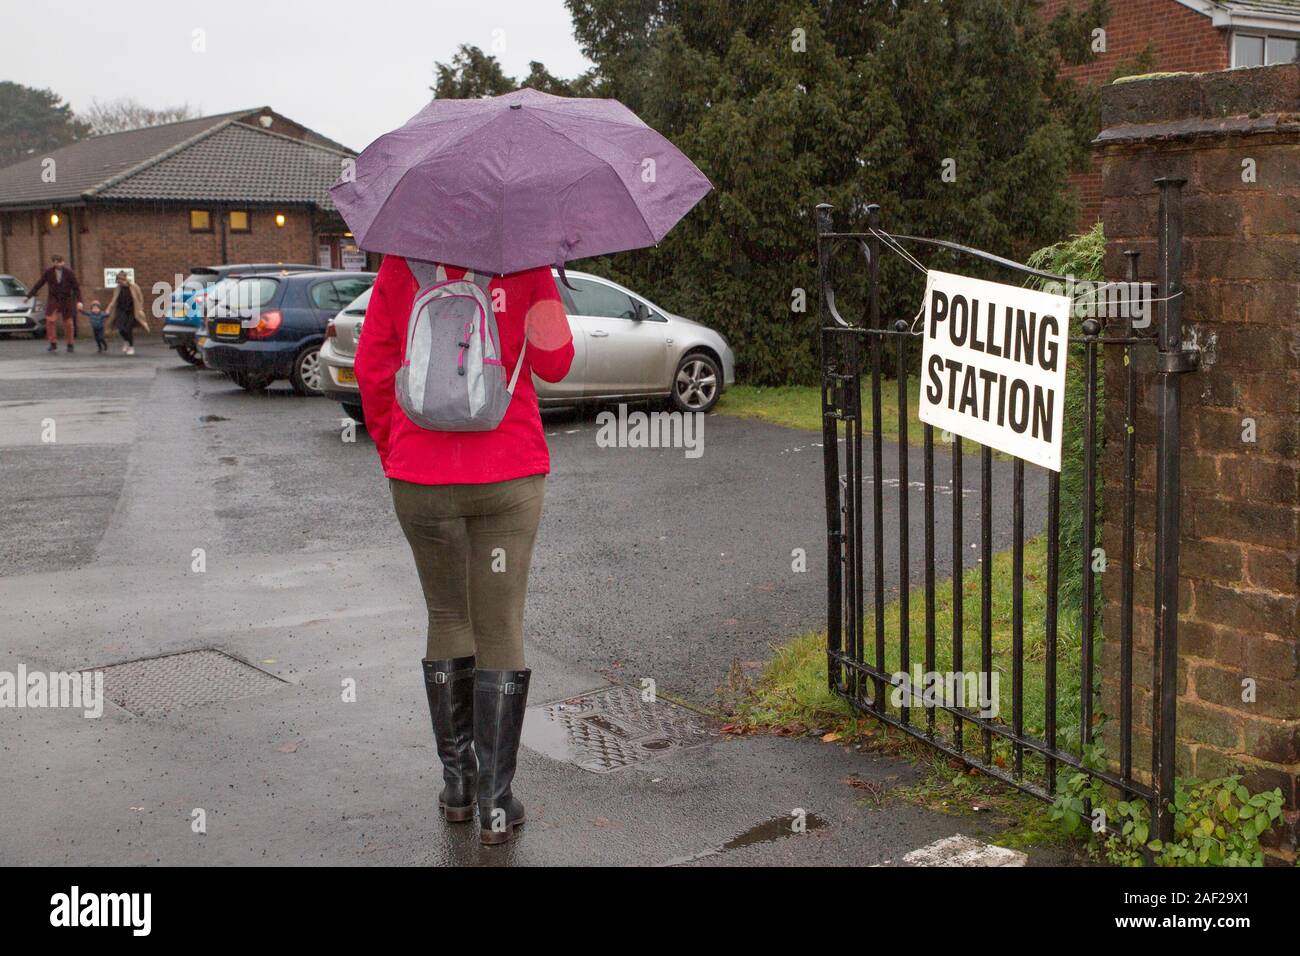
[330,90,712,274]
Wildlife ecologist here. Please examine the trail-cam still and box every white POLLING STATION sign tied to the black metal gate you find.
[920,269,1070,471]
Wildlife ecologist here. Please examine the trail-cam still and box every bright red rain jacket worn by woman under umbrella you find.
[356,255,573,485]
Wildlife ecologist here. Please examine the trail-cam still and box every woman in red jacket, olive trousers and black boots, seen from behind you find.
[356,255,573,844]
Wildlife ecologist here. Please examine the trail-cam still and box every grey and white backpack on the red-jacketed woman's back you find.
[397,259,528,432]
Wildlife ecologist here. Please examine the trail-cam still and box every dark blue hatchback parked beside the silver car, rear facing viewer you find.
[203,272,374,395]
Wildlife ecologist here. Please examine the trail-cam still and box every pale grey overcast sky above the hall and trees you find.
[0,0,590,150]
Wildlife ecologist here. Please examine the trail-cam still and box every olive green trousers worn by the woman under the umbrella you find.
[389,475,546,670]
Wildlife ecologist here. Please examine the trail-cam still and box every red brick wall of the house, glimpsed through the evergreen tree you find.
[1043,0,1231,232]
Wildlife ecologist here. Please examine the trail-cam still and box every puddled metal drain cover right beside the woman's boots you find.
[524,687,714,774]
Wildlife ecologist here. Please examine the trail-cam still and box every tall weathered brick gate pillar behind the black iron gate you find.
[1097,64,1300,860]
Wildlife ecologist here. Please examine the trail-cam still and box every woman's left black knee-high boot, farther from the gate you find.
[423,657,477,823]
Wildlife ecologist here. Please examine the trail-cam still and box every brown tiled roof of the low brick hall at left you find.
[0,111,352,209]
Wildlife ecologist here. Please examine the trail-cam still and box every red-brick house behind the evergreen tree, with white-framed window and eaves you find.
[1043,0,1300,232]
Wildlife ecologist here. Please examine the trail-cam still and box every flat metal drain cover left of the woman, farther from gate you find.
[90,649,285,717]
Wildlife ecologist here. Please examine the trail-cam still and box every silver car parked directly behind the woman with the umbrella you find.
[321,272,736,421]
